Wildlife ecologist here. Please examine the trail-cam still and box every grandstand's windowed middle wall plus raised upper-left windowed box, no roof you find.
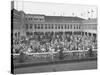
[25,15,83,32]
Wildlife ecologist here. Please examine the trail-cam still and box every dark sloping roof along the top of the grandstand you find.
[11,9,85,23]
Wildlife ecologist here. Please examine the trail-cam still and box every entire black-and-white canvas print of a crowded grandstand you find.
[11,0,98,74]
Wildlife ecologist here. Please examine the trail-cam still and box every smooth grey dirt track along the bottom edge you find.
[14,60,97,74]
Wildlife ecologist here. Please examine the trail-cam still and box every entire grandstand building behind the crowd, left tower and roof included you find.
[12,9,97,36]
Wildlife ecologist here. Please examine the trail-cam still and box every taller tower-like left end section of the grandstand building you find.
[11,9,25,37]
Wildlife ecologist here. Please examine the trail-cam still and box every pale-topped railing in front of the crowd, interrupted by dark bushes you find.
[13,49,97,61]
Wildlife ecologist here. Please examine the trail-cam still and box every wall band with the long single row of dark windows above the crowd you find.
[26,23,82,32]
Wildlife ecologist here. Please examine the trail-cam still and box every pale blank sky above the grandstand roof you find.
[14,1,97,19]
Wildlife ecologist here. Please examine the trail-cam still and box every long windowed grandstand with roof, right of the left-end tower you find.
[24,14,97,34]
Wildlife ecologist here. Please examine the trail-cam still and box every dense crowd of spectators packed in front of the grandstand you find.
[13,32,97,53]
